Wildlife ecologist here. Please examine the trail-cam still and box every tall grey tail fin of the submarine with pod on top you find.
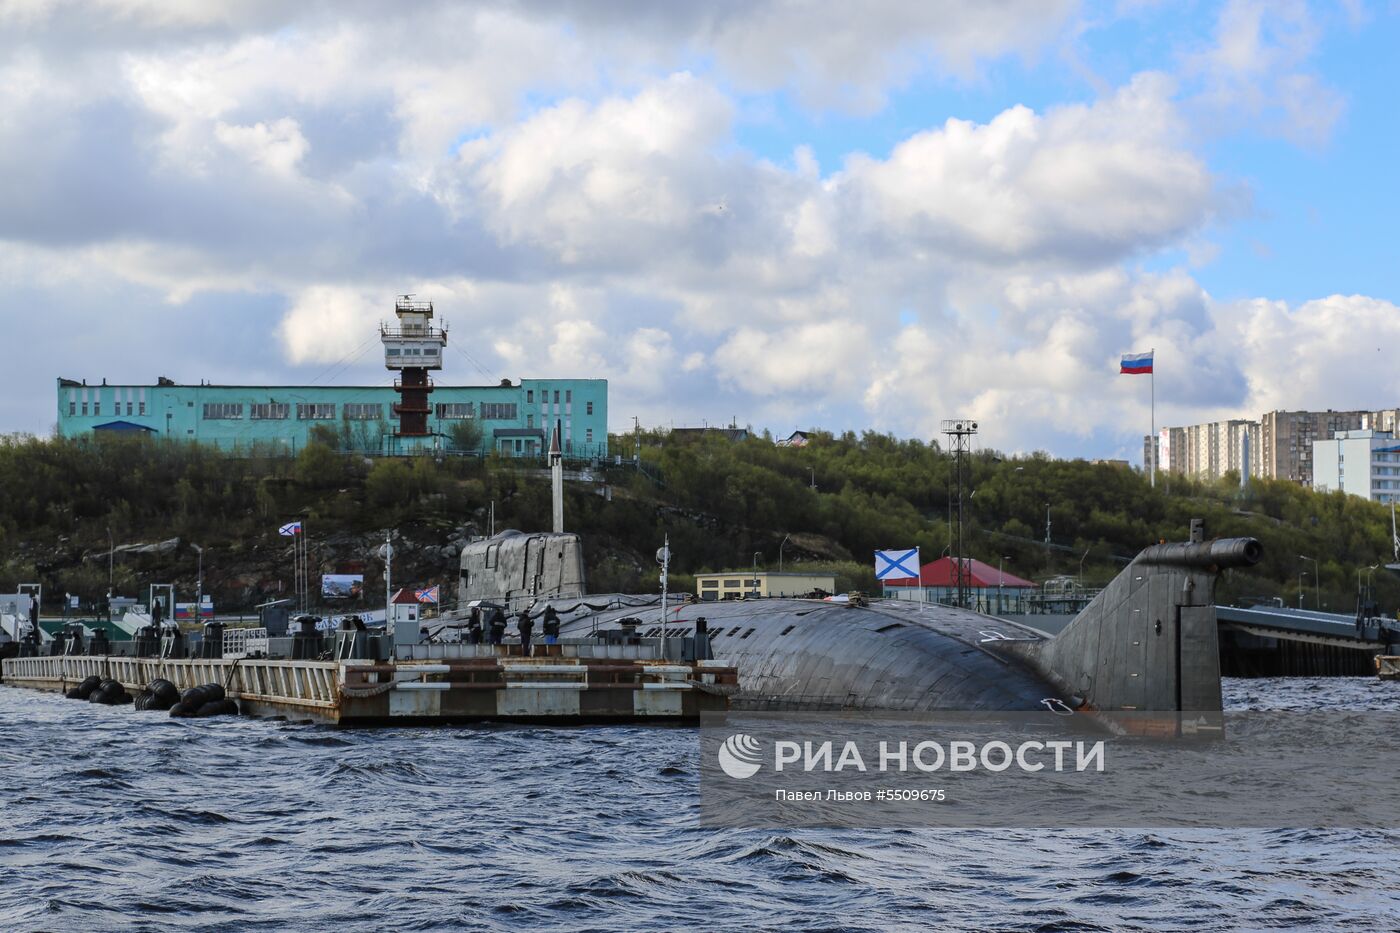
[1016,520,1264,712]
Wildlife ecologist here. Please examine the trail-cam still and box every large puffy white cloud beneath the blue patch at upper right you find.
[840,74,1212,262]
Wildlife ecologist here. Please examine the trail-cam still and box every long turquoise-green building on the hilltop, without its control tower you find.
[57,377,608,459]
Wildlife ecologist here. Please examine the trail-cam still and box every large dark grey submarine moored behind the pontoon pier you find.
[435,515,1263,713]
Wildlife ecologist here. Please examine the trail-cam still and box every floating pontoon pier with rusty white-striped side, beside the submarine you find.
[3,639,738,726]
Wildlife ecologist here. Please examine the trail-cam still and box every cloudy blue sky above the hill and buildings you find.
[0,0,1400,462]
